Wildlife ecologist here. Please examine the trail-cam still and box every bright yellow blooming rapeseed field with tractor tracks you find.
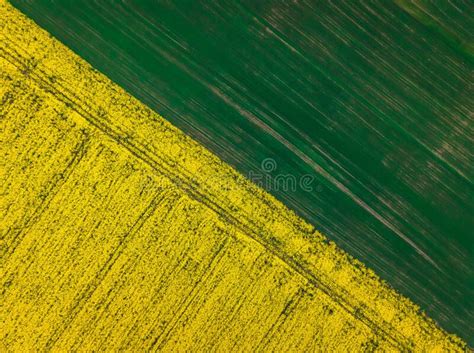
[0,1,466,352]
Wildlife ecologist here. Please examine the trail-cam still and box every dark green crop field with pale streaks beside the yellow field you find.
[7,0,474,343]
